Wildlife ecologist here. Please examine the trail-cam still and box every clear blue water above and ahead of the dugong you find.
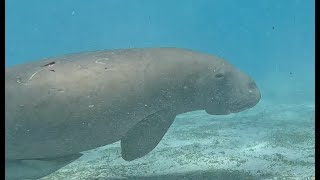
[5,0,315,179]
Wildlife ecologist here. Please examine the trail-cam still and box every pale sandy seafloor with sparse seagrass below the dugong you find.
[41,102,315,180]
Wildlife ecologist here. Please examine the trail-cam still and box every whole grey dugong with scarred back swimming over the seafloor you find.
[5,47,261,179]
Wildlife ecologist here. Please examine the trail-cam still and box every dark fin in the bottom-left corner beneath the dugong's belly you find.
[5,153,82,180]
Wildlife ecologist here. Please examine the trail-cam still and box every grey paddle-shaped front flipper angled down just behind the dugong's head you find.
[121,110,176,161]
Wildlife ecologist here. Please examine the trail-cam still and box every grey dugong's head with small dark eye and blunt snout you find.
[197,59,261,115]
